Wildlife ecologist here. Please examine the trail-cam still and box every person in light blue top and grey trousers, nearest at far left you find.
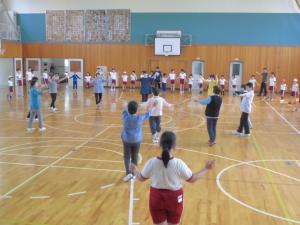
[27,77,46,133]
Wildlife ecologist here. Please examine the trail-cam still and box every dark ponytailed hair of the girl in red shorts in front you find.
[160,131,176,168]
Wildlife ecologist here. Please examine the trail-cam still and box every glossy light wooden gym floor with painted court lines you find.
[0,85,300,225]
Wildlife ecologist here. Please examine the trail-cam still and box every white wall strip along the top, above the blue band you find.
[7,0,299,13]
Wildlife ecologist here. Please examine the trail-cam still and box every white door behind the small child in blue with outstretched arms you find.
[65,59,84,89]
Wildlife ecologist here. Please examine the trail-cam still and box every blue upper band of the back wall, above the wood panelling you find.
[18,13,300,45]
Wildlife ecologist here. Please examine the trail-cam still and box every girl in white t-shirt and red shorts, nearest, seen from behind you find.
[131,131,215,225]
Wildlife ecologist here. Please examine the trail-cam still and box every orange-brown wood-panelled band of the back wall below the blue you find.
[23,44,300,87]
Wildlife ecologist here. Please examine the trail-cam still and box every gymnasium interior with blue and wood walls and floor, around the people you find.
[0,0,300,225]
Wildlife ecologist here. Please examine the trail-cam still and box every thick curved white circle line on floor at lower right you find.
[216,159,300,224]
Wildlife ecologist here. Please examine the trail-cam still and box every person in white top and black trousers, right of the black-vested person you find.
[233,83,254,137]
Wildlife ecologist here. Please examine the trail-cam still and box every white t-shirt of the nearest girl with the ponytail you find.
[141,158,193,191]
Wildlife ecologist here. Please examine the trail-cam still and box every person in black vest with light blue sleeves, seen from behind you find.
[198,86,222,146]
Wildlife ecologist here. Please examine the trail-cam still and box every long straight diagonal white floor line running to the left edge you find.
[0,127,110,200]
